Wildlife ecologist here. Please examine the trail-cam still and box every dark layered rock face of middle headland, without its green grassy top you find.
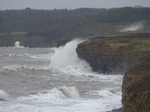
[76,41,147,74]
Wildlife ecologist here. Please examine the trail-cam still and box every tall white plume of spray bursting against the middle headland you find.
[50,39,90,68]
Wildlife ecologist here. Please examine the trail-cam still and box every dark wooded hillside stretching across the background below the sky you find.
[0,7,150,47]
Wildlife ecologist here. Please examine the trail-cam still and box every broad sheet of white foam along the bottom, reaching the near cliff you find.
[12,86,121,112]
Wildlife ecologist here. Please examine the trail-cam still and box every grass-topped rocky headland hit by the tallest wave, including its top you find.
[76,37,150,74]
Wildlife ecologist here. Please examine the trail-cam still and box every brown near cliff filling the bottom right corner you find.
[122,55,150,112]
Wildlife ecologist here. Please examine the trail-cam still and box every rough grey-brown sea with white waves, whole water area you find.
[0,40,123,112]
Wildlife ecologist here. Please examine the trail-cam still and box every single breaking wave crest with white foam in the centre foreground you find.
[19,86,80,102]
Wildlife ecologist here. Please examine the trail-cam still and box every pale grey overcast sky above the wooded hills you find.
[0,0,150,10]
